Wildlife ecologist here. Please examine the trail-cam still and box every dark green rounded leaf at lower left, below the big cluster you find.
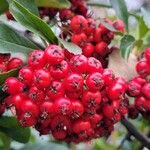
[0,116,30,143]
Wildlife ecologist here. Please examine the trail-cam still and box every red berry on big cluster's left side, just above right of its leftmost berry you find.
[19,67,33,86]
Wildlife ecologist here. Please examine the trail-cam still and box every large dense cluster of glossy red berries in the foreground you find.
[3,45,128,143]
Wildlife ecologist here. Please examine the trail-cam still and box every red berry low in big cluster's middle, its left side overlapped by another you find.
[70,100,84,119]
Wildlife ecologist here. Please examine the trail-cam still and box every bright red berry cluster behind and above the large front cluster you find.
[66,15,124,67]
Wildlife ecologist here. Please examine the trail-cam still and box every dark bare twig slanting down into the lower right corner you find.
[122,118,150,149]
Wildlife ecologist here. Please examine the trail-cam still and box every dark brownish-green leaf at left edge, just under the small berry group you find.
[0,69,18,85]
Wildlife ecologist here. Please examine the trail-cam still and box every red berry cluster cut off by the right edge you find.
[127,48,150,120]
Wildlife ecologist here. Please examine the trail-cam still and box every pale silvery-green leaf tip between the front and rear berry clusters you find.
[59,38,82,55]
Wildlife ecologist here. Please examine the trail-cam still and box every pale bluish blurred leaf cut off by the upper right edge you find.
[141,4,150,28]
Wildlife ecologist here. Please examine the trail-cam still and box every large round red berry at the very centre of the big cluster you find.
[65,73,83,92]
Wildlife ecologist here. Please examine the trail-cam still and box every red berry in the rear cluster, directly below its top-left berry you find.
[71,33,87,46]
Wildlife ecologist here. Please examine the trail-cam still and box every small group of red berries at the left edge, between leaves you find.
[0,54,23,73]
